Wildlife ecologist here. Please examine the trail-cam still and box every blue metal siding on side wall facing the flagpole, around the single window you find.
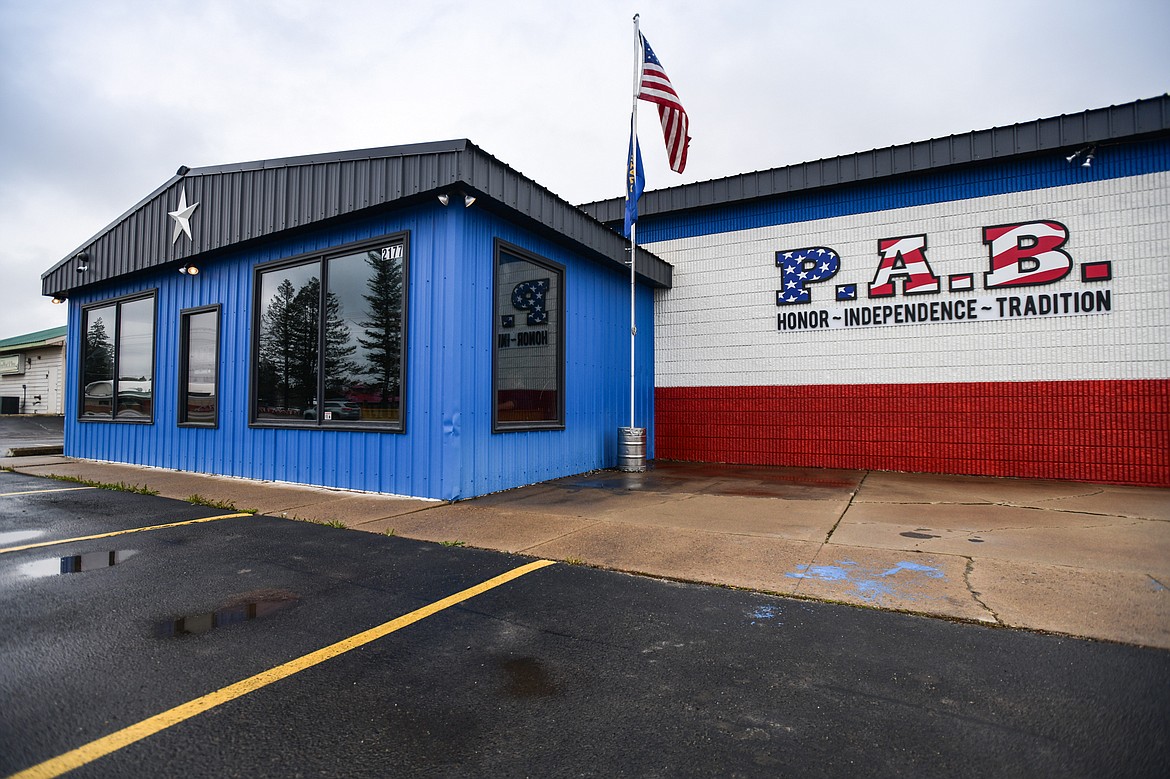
[450,208,654,497]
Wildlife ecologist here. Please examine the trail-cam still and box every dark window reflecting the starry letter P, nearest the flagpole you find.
[491,241,565,432]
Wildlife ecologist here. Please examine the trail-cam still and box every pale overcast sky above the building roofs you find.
[0,0,1170,338]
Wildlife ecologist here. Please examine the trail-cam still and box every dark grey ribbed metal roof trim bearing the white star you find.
[41,139,672,295]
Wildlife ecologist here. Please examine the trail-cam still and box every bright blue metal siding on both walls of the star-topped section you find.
[66,198,653,499]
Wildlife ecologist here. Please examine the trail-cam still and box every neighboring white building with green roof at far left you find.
[0,328,68,414]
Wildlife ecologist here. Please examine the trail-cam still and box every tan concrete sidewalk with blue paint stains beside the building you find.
[0,457,1170,649]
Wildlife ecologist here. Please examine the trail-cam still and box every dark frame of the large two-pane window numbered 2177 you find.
[248,230,411,433]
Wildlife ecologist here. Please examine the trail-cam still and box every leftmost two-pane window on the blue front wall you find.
[81,292,154,422]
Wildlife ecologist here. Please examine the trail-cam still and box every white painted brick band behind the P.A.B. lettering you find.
[646,172,1170,387]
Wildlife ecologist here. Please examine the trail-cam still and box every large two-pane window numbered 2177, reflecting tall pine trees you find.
[253,236,407,430]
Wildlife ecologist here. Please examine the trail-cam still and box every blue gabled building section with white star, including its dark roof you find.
[43,140,670,499]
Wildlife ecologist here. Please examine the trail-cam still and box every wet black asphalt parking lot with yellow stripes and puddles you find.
[0,473,1170,777]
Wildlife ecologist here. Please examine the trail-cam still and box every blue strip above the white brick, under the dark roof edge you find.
[638,135,1170,239]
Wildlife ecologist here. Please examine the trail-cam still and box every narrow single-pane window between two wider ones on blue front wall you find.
[179,305,220,427]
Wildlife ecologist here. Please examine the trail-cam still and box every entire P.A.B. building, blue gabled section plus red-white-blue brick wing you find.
[43,96,1170,491]
